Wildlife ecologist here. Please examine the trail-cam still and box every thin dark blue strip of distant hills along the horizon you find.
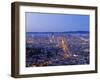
[27,31,89,34]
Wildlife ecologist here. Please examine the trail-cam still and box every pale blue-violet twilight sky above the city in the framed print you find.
[25,12,90,32]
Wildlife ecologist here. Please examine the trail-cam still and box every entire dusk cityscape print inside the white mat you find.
[25,12,90,67]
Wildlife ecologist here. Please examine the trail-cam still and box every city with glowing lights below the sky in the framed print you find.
[26,32,89,67]
